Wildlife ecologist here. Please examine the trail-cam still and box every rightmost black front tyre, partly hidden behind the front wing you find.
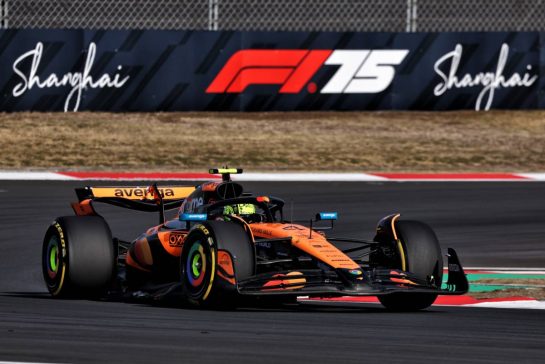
[378,220,443,311]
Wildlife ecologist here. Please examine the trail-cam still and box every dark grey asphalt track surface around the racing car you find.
[0,181,545,363]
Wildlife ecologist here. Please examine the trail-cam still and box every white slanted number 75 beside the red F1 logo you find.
[320,49,409,94]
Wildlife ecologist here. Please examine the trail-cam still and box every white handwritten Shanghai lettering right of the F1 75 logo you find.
[433,43,538,111]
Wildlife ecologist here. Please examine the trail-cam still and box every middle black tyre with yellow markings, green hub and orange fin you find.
[180,221,255,308]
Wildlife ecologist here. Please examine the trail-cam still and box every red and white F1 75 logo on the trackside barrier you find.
[206,49,409,94]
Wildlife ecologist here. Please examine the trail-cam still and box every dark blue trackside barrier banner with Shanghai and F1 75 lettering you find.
[0,29,545,112]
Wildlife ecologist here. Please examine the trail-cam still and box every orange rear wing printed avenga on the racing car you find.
[72,184,195,220]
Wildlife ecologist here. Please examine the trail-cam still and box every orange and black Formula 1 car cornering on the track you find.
[42,168,469,311]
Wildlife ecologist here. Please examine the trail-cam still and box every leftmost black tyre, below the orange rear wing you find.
[42,216,115,298]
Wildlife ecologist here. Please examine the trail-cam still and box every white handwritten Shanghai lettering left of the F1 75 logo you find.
[12,42,129,111]
